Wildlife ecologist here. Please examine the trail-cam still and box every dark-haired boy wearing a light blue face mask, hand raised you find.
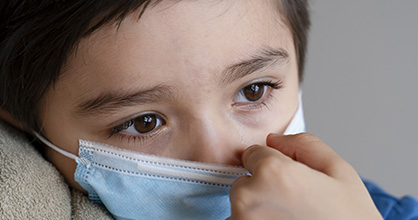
[0,0,416,219]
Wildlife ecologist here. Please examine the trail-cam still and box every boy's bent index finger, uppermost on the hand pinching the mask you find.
[266,133,355,178]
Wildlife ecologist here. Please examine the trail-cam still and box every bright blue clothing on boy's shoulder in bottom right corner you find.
[363,181,418,220]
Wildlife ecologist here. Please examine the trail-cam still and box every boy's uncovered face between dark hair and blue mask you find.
[41,0,298,189]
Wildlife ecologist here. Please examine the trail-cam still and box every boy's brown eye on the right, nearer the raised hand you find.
[234,82,281,104]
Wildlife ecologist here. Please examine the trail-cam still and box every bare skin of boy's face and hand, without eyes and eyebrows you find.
[2,0,381,219]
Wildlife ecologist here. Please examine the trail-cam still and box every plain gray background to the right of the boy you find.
[302,0,418,198]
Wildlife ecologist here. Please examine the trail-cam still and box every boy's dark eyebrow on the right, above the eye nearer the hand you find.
[220,47,289,85]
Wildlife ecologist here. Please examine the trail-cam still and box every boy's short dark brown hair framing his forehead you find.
[0,0,310,130]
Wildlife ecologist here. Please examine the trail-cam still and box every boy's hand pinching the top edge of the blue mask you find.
[229,133,382,220]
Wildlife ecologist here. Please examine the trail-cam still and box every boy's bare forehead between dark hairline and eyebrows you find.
[62,0,294,89]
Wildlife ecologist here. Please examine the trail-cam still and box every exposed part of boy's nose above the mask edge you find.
[190,111,244,165]
